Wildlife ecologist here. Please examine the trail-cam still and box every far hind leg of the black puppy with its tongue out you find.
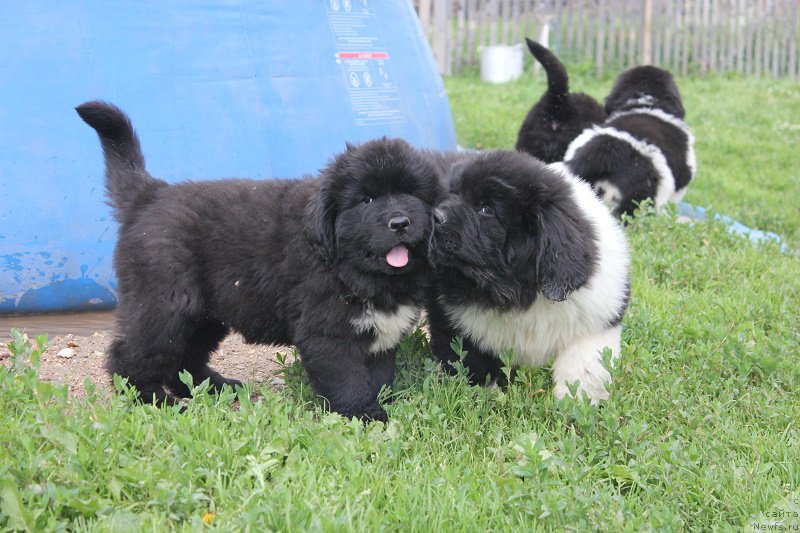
[167,321,242,398]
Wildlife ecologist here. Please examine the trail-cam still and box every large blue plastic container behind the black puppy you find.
[0,0,456,314]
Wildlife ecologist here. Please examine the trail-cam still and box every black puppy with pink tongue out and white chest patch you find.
[77,102,440,420]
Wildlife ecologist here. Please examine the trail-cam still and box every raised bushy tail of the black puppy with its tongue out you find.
[75,100,166,221]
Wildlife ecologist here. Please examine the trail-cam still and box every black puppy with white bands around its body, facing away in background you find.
[564,66,697,214]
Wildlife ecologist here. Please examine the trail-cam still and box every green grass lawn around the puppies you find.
[0,72,800,531]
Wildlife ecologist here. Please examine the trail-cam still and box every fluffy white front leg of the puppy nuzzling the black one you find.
[553,326,622,405]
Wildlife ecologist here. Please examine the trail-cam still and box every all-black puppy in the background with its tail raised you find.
[516,39,606,163]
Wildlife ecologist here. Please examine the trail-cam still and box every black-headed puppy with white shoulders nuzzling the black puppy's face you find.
[428,151,630,403]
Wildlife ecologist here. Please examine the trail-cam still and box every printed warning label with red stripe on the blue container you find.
[327,0,406,126]
